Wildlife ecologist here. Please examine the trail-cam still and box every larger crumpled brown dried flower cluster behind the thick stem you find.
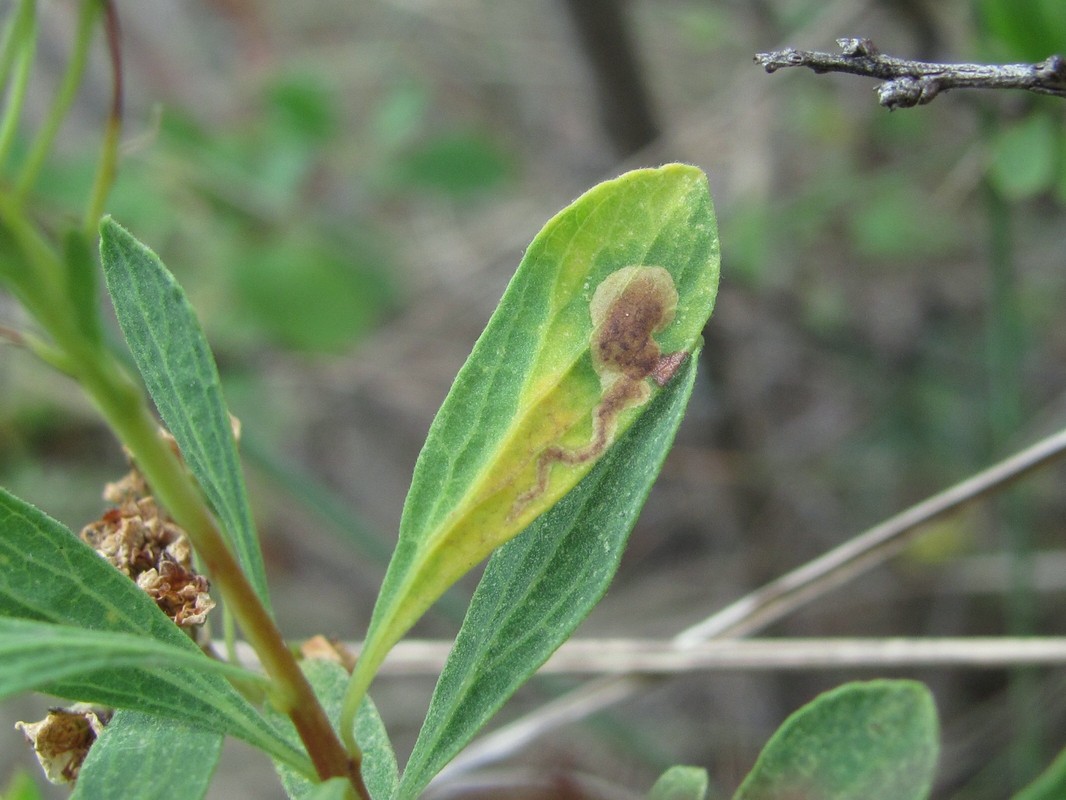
[81,467,214,630]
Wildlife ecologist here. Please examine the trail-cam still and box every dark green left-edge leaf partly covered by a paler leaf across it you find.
[0,490,310,771]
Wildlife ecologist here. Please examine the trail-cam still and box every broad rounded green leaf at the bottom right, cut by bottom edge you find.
[733,681,939,800]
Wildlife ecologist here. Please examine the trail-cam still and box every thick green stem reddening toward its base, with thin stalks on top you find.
[0,0,370,800]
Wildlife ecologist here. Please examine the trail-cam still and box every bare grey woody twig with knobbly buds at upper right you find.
[755,38,1066,110]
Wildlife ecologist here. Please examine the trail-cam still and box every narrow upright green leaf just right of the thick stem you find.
[100,218,268,603]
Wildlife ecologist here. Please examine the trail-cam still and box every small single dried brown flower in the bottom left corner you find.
[15,704,111,784]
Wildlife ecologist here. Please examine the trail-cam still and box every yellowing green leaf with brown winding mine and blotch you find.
[345,164,718,725]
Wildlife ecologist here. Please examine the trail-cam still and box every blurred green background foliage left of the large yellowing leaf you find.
[25,67,514,353]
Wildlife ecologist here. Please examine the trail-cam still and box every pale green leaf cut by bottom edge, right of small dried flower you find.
[70,710,223,800]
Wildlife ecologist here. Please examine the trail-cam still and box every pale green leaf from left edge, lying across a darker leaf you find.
[0,617,269,698]
